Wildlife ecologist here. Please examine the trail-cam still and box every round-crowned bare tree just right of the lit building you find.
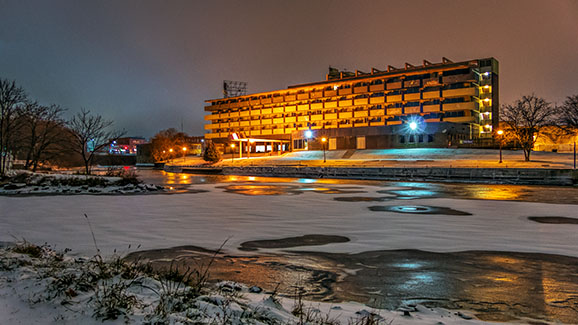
[500,94,557,161]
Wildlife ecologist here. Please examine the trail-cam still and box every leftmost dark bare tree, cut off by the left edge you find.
[0,79,26,176]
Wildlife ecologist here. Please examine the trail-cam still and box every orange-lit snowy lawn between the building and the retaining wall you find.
[171,148,574,169]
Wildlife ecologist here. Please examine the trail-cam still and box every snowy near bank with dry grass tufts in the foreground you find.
[0,240,483,325]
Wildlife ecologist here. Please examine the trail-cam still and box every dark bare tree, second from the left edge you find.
[19,102,64,171]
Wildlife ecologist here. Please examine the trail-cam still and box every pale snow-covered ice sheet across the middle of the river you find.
[0,184,578,256]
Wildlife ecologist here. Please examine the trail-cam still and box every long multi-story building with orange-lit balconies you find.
[205,58,499,150]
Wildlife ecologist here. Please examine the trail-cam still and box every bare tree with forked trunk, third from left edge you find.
[67,109,123,175]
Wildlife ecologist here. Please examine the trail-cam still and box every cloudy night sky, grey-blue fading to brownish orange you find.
[0,0,578,137]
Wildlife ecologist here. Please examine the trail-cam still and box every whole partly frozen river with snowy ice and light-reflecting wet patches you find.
[0,171,578,321]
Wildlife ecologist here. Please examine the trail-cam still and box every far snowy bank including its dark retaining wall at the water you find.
[165,148,578,186]
